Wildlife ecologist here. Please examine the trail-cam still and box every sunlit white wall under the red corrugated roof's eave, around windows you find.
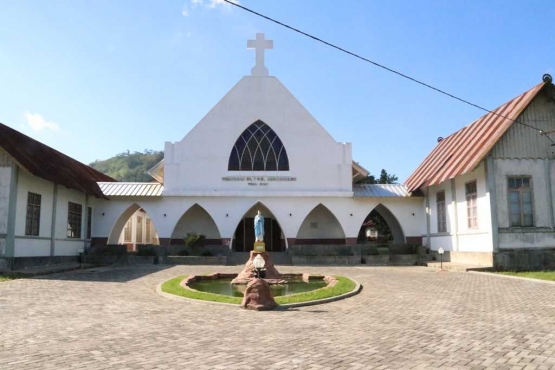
[423,162,493,252]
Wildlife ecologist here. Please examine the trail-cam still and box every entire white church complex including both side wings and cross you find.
[0,34,555,266]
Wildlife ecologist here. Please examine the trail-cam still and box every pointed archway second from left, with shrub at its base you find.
[170,203,222,245]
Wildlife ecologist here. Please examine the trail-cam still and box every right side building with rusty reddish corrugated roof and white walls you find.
[405,75,555,269]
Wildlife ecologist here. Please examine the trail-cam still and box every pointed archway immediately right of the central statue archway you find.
[295,203,345,245]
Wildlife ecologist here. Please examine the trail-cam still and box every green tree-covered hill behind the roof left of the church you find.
[90,150,164,182]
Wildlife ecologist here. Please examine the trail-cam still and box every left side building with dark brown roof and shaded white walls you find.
[0,124,115,271]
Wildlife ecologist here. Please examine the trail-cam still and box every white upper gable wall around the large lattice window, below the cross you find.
[164,76,352,196]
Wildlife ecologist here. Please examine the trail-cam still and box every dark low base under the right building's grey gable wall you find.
[493,248,555,271]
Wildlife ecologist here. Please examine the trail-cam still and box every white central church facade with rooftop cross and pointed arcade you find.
[93,34,423,251]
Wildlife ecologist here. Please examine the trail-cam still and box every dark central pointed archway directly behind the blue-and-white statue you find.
[232,202,287,252]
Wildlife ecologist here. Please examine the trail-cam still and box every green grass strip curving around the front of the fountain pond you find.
[162,275,356,305]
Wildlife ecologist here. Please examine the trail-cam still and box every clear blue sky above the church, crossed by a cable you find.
[0,0,555,181]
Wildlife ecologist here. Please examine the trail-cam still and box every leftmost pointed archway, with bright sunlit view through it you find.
[108,203,160,251]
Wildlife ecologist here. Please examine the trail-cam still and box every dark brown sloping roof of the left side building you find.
[0,123,116,198]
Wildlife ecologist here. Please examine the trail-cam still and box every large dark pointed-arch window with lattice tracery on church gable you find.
[227,120,289,171]
